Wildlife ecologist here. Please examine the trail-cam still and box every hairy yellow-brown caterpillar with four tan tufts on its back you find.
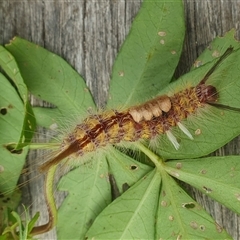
[40,47,233,172]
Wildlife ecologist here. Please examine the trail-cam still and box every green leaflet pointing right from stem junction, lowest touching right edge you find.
[165,156,240,214]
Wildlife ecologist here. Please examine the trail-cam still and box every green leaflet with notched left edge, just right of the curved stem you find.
[57,155,111,239]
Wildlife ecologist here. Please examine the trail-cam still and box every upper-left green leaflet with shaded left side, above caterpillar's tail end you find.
[6,37,95,125]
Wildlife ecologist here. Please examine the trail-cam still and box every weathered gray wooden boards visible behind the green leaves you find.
[0,0,240,239]
